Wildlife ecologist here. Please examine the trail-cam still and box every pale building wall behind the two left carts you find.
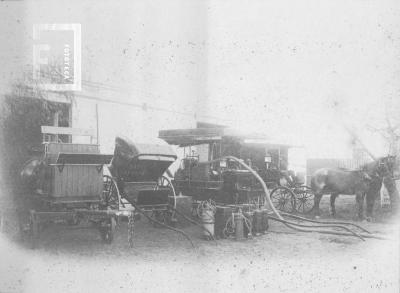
[72,96,195,153]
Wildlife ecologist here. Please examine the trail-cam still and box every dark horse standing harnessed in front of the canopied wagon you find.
[311,156,395,220]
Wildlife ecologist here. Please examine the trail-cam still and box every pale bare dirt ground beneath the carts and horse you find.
[0,196,400,292]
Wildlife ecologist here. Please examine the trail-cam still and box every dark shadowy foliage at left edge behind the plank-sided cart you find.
[0,71,69,192]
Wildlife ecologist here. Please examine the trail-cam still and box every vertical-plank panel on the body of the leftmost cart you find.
[45,165,103,197]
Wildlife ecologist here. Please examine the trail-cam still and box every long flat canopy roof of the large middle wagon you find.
[158,127,291,147]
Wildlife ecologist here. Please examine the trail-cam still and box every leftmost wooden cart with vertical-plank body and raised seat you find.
[23,126,119,247]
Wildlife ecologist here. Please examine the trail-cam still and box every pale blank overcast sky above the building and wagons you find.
[0,0,400,157]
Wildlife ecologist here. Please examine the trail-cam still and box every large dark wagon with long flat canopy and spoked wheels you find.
[159,126,313,212]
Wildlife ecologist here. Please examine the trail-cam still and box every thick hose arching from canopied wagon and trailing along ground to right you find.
[200,156,384,241]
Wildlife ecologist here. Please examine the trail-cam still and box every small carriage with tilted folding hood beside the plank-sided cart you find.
[108,137,177,224]
